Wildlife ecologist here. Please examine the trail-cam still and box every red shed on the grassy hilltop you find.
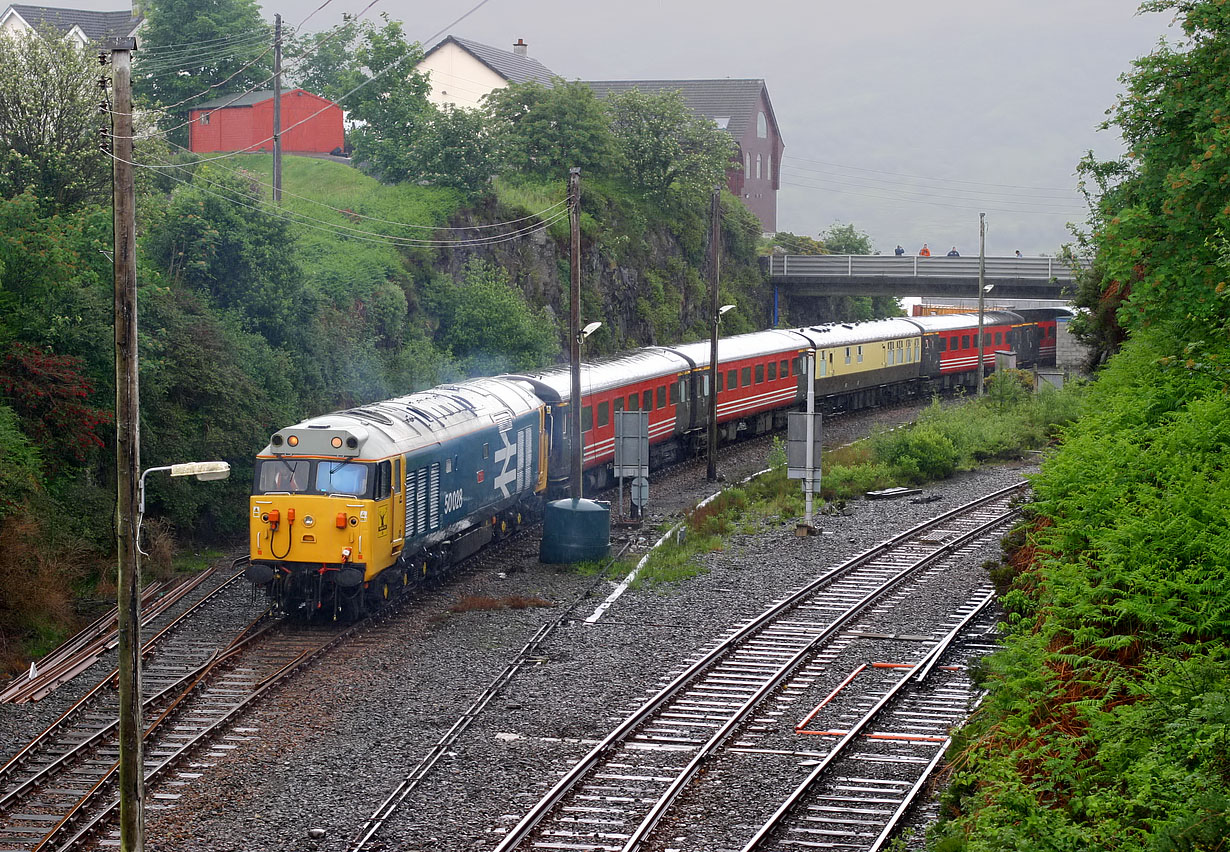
[188,89,346,154]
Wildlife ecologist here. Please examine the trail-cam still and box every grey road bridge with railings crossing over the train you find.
[769,254,1089,300]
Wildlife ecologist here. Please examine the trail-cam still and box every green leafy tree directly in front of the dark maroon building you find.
[606,89,736,207]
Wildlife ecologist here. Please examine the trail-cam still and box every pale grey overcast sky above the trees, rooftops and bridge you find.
[84,0,1181,254]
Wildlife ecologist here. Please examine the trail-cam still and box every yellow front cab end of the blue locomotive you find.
[247,424,401,616]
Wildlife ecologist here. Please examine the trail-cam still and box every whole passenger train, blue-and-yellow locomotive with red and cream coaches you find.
[247,311,1057,620]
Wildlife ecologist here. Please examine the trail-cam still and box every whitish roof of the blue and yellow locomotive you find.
[260,379,541,459]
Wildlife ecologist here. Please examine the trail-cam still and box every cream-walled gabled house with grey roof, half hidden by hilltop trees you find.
[415,36,556,108]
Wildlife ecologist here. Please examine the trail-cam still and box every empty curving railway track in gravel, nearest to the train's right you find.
[496,483,1025,852]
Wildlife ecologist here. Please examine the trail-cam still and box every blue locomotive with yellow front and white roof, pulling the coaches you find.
[247,379,549,620]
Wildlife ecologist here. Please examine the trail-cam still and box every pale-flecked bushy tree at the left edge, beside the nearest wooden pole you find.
[0,30,111,210]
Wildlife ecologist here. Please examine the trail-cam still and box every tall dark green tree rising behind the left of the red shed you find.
[133,0,273,145]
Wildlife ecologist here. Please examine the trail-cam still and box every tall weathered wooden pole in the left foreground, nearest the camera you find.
[109,38,145,852]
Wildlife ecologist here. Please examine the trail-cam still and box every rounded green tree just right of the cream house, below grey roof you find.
[485,77,617,178]
